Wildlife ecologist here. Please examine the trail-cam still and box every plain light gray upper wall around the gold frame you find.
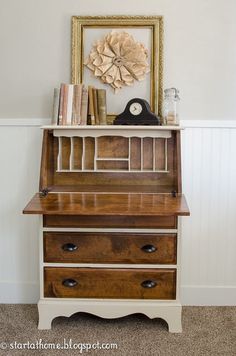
[0,0,236,120]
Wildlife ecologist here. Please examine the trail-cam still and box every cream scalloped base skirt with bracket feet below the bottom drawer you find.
[38,298,182,333]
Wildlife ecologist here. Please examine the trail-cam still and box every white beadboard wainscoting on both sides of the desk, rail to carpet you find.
[0,119,236,305]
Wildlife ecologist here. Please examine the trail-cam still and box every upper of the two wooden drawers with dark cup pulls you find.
[44,232,177,264]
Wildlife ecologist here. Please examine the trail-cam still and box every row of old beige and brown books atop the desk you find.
[52,83,107,125]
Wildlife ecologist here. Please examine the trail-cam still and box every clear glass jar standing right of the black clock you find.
[162,88,180,125]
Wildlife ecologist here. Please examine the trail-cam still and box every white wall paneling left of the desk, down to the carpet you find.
[0,126,42,302]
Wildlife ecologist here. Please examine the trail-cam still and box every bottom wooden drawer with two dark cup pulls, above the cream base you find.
[44,267,176,299]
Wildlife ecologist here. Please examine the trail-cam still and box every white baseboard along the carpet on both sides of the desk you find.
[0,282,236,306]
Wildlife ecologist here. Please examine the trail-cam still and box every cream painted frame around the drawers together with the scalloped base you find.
[38,218,182,333]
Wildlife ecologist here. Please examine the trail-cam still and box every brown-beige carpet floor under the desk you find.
[0,304,236,356]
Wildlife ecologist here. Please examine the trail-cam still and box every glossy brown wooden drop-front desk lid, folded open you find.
[23,192,190,216]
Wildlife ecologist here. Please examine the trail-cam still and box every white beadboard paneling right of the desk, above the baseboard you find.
[182,128,236,290]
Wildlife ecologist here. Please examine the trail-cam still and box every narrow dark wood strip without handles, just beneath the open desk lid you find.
[43,215,177,229]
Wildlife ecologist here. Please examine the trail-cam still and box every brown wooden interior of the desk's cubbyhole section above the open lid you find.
[40,130,181,193]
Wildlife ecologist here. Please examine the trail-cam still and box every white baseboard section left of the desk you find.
[0,282,39,304]
